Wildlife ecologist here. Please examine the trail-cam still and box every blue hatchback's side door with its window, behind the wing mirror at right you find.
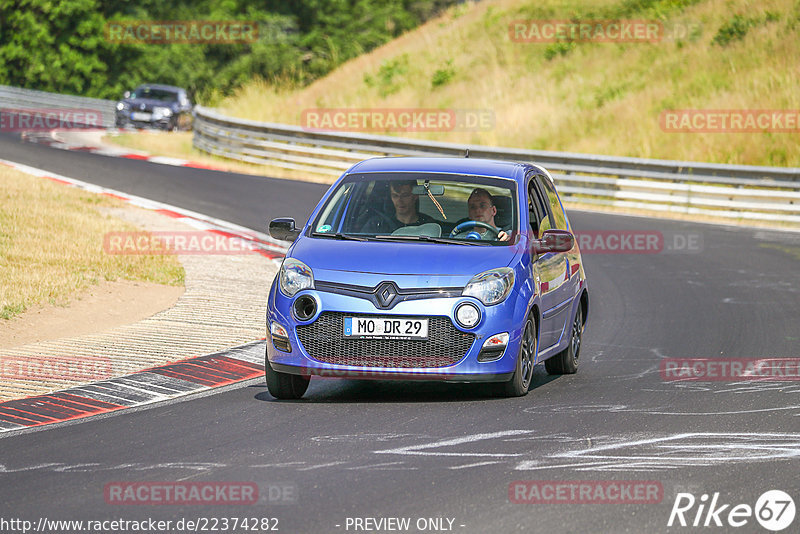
[528,174,572,351]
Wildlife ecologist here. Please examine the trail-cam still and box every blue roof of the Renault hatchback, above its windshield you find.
[348,157,532,179]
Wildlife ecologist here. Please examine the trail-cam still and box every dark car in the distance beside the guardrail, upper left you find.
[116,84,193,131]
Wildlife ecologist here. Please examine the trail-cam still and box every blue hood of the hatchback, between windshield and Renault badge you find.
[289,237,519,277]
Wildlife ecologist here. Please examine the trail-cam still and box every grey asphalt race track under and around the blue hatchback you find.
[0,136,800,533]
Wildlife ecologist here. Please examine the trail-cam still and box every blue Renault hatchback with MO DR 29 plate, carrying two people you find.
[266,157,589,399]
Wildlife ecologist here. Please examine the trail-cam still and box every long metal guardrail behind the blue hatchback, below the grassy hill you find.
[194,106,800,224]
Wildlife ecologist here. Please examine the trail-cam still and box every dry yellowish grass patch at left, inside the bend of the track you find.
[0,166,184,320]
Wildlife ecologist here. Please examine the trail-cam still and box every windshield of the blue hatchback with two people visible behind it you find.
[311,173,519,245]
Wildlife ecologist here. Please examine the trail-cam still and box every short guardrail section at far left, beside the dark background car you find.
[0,85,116,128]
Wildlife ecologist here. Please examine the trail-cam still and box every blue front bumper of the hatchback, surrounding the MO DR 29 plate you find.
[267,282,526,382]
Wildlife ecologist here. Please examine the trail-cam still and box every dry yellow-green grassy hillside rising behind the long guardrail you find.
[220,0,800,166]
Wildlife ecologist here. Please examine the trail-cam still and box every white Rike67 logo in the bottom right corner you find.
[667,490,796,532]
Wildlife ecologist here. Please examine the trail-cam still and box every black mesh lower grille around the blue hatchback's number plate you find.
[297,312,475,368]
